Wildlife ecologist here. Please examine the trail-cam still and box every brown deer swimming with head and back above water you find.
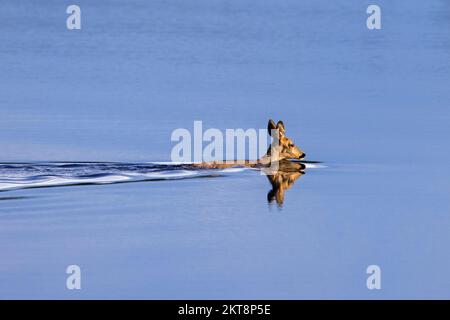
[193,119,305,169]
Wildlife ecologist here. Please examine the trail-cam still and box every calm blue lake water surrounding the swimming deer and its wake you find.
[0,0,450,299]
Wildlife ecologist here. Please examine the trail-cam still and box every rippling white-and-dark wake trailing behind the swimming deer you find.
[0,162,324,192]
